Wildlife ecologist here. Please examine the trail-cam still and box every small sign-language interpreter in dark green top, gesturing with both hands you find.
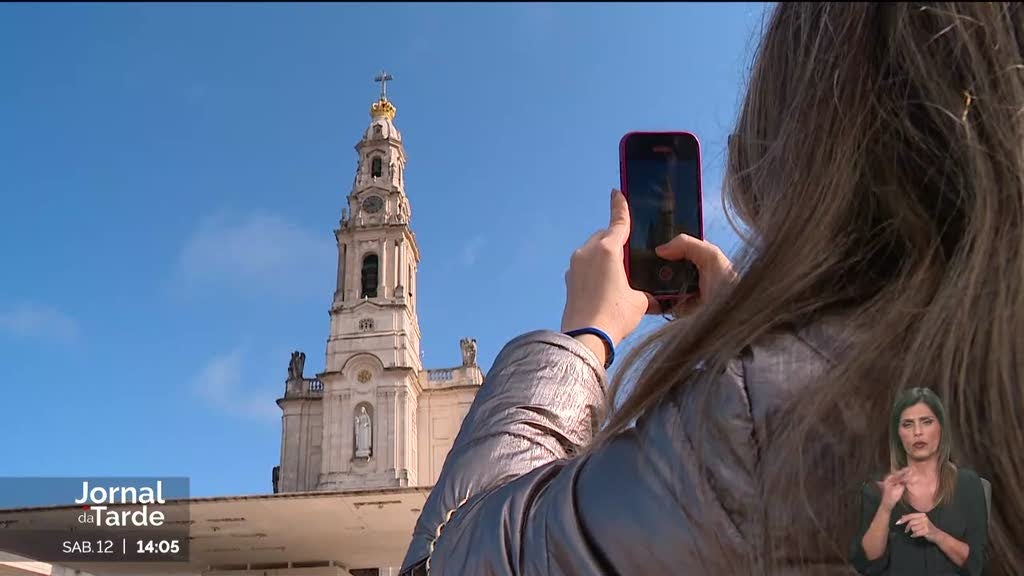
[851,387,988,576]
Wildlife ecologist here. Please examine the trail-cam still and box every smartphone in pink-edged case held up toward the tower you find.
[618,132,703,311]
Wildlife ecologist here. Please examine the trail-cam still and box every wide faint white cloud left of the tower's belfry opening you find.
[178,213,337,291]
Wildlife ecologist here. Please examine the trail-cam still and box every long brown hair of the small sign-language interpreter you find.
[889,387,956,505]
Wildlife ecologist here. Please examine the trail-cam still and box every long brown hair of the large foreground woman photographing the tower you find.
[590,2,1024,574]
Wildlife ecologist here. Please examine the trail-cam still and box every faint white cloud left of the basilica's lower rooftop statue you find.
[193,347,281,420]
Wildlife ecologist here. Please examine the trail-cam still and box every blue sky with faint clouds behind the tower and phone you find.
[0,4,766,496]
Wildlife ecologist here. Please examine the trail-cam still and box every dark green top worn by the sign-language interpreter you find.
[850,468,988,576]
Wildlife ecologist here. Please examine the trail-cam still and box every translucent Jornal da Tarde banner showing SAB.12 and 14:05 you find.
[0,478,190,563]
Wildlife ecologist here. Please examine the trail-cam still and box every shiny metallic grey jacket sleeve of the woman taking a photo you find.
[402,331,760,576]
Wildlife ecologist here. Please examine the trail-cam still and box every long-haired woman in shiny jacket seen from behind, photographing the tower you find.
[403,3,1024,576]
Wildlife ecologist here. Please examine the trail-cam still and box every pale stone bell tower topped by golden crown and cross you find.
[317,72,422,483]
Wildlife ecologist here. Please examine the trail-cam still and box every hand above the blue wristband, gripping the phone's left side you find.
[562,190,657,344]
